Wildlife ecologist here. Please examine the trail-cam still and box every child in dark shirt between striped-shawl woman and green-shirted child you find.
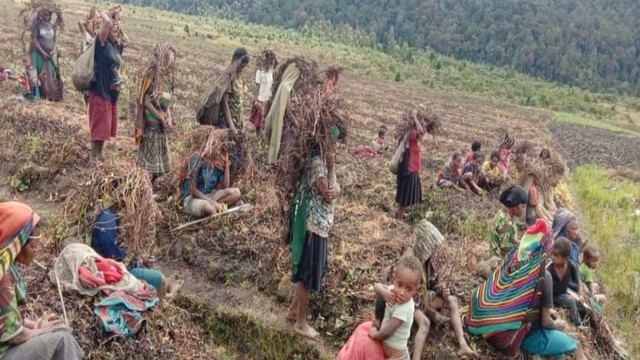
[547,237,585,326]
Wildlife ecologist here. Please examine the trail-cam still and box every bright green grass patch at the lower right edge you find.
[573,165,640,358]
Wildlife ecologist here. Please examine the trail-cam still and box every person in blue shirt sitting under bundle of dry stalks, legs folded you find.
[180,146,242,218]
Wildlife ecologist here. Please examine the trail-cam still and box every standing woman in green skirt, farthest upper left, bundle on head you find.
[31,4,64,101]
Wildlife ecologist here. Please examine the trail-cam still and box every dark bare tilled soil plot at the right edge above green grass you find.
[548,122,640,169]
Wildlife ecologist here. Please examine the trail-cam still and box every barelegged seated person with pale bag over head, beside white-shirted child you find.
[405,220,478,360]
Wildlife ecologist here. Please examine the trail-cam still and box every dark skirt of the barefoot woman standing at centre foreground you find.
[291,231,327,291]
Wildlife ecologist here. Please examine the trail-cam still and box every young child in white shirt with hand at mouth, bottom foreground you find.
[369,255,422,360]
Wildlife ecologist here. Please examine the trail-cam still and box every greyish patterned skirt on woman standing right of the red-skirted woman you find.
[138,127,171,176]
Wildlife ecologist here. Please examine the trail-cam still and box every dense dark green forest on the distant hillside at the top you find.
[117,0,640,94]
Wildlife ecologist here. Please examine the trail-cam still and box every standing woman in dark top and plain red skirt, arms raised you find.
[89,11,125,163]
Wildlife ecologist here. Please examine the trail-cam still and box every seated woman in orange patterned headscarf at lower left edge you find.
[0,202,84,360]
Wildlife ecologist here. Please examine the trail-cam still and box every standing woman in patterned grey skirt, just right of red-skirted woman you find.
[136,42,175,186]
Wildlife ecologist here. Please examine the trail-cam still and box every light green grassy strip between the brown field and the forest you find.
[102,1,640,128]
